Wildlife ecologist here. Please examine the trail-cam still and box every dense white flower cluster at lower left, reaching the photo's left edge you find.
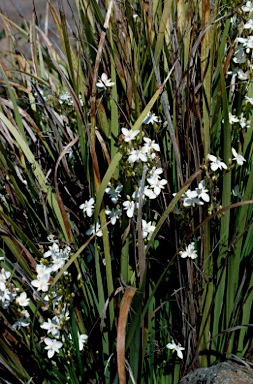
[0,235,88,359]
